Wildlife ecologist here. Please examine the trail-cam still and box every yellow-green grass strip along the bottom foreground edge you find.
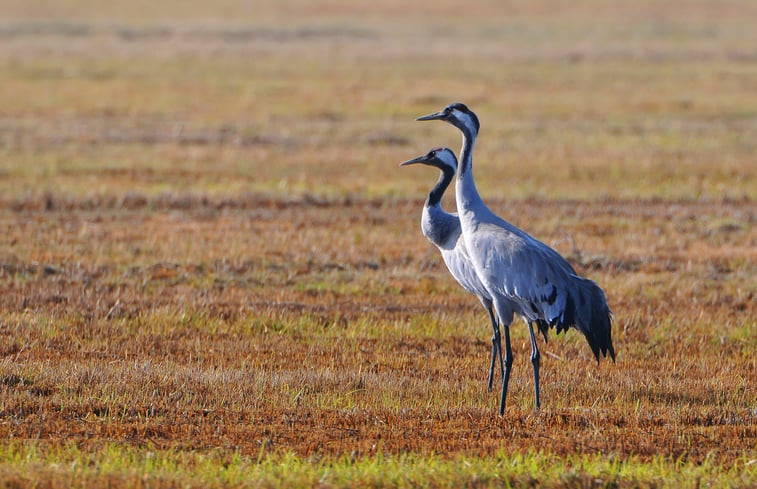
[0,442,757,488]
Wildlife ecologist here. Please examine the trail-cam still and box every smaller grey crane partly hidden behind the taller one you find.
[400,148,504,391]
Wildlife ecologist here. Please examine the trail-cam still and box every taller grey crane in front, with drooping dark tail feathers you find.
[417,103,615,414]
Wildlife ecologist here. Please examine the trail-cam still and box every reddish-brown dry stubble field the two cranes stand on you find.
[1,193,757,463]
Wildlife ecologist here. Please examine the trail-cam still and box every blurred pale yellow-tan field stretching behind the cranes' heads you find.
[0,0,757,204]
